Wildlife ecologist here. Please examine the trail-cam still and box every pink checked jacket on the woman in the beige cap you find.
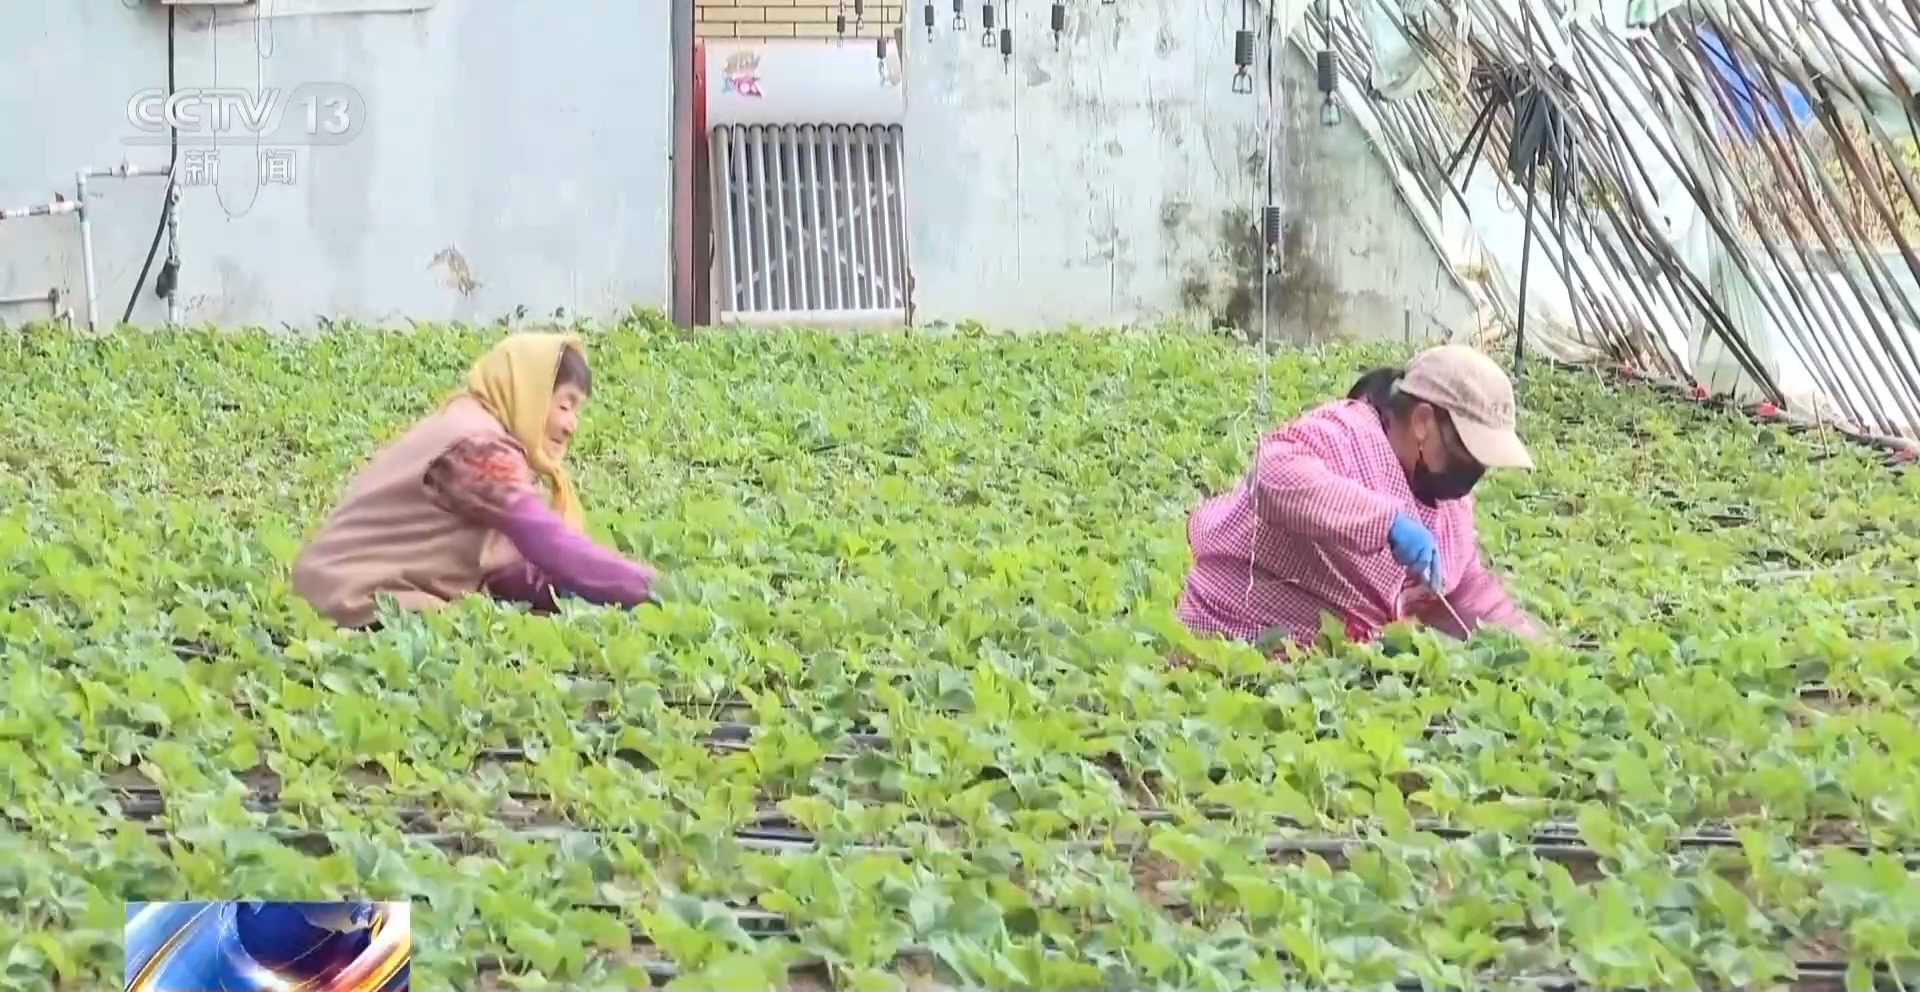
[1179,399,1532,643]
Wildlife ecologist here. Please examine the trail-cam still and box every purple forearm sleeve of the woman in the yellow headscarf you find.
[490,493,655,606]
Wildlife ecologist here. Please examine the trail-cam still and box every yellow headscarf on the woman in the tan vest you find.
[449,334,588,530]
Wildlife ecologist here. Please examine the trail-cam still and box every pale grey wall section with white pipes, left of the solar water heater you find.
[0,0,672,324]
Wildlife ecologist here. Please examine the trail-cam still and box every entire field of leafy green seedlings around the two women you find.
[0,317,1920,992]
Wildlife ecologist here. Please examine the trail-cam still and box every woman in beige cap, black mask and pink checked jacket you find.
[1179,345,1540,643]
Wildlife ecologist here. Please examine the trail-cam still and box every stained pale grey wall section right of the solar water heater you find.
[906,0,1471,342]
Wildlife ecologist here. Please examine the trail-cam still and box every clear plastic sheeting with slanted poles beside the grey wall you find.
[1294,0,1920,437]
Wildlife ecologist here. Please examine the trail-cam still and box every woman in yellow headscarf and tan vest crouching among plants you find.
[292,334,655,627]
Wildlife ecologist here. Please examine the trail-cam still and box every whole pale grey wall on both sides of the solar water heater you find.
[0,0,1471,342]
